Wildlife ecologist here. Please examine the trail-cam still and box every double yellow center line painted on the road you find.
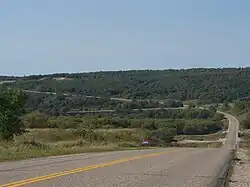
[0,150,177,187]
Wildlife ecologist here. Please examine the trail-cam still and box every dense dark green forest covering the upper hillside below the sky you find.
[2,68,250,103]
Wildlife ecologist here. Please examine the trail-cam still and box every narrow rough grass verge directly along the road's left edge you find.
[0,142,146,162]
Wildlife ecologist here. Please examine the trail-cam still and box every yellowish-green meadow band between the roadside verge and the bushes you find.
[15,128,141,143]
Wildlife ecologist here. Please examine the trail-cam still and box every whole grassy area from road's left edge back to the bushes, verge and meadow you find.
[0,129,152,161]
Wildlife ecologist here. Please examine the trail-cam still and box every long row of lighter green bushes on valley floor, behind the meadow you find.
[22,106,224,134]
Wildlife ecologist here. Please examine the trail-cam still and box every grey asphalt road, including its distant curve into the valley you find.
[0,114,238,187]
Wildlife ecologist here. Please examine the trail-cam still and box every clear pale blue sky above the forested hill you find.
[0,0,250,76]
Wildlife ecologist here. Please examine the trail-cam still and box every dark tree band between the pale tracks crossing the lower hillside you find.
[22,93,183,116]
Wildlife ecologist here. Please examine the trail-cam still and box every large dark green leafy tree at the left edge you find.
[0,90,26,140]
